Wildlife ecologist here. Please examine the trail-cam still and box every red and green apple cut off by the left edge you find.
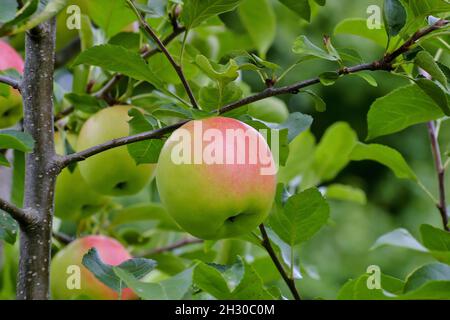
[0,40,24,129]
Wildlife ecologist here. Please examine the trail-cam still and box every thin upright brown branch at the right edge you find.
[428,121,450,231]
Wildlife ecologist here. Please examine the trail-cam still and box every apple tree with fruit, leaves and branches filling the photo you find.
[0,0,450,300]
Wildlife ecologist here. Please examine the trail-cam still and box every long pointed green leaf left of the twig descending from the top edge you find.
[74,44,163,87]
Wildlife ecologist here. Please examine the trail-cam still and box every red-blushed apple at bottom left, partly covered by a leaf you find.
[50,236,136,300]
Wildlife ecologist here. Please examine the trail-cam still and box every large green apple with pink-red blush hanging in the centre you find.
[156,117,276,240]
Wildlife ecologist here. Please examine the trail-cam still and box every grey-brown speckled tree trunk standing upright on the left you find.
[17,19,59,300]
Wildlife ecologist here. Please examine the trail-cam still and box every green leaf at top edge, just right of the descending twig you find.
[181,0,242,29]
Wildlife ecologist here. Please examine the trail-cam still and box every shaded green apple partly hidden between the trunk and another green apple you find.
[55,133,108,222]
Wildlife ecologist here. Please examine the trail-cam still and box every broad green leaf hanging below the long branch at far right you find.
[367,84,444,140]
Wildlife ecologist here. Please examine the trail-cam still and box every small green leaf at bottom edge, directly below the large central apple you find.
[193,262,231,300]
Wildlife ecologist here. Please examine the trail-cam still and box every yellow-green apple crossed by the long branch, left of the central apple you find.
[77,106,156,196]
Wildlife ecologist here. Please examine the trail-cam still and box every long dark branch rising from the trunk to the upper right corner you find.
[60,20,447,168]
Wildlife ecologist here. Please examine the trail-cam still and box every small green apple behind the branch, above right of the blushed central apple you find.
[248,97,289,123]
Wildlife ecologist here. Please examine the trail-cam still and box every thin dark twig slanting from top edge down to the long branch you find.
[127,0,198,109]
